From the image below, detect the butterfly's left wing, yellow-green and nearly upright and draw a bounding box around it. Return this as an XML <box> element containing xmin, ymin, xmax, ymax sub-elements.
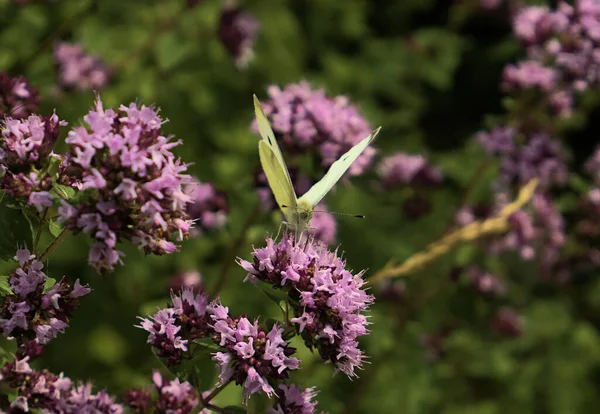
<box><xmin>254</xmin><ymin>95</ymin><xmax>298</xmax><ymax>220</ymax></box>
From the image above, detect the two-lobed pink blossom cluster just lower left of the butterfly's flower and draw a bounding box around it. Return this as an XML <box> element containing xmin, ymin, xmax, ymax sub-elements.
<box><xmin>140</xmin><ymin>288</ymin><xmax>299</xmax><ymax>400</ymax></box>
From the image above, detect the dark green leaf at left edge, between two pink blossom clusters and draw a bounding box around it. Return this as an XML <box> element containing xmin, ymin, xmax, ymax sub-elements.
<box><xmin>0</xmin><ymin>197</ymin><xmax>33</xmax><ymax>261</ymax></box>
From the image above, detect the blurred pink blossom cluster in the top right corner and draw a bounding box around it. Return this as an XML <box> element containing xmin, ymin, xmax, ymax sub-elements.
<box><xmin>504</xmin><ymin>0</ymin><xmax>600</xmax><ymax>117</ymax></box>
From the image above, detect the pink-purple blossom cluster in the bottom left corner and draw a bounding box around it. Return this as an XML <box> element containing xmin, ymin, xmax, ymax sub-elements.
<box><xmin>0</xmin><ymin>357</ymin><xmax>124</xmax><ymax>414</ymax></box>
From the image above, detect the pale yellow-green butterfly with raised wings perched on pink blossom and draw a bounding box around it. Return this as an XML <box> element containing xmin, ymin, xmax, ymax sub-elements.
<box><xmin>254</xmin><ymin>95</ymin><xmax>381</xmax><ymax>240</ymax></box>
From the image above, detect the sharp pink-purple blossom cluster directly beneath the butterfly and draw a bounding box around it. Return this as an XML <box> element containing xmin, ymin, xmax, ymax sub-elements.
<box><xmin>238</xmin><ymin>235</ymin><xmax>373</xmax><ymax>377</ymax></box>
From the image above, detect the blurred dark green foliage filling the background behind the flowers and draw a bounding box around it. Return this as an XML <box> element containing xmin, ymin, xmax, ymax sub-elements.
<box><xmin>0</xmin><ymin>0</ymin><xmax>600</xmax><ymax>414</ymax></box>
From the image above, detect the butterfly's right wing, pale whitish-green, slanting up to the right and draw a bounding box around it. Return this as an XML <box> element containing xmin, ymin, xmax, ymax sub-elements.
<box><xmin>298</xmin><ymin>127</ymin><xmax>381</xmax><ymax>209</ymax></box>
